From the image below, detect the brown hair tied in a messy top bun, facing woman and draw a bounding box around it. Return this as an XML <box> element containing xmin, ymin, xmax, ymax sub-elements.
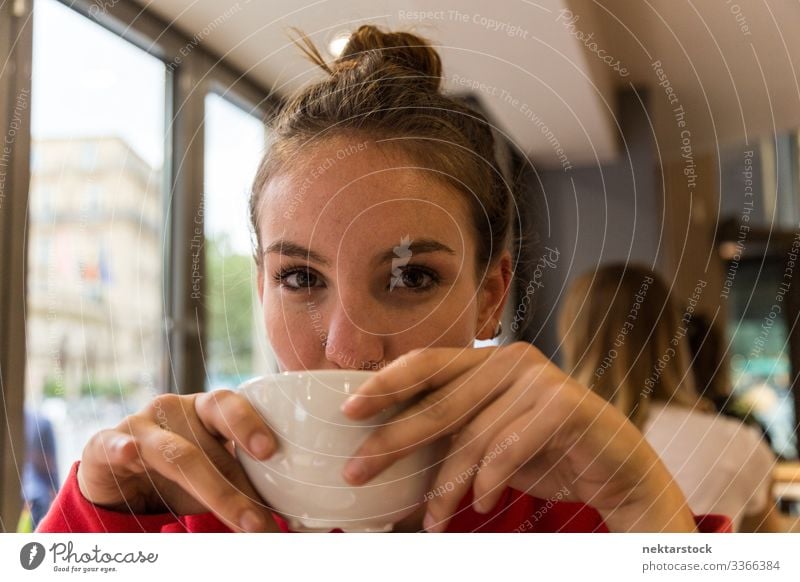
<box><xmin>250</xmin><ymin>25</ymin><xmax>513</xmax><ymax>274</ymax></box>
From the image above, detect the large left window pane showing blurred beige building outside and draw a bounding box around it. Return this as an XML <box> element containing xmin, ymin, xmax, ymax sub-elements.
<box><xmin>23</xmin><ymin>0</ymin><xmax>166</xmax><ymax>532</ymax></box>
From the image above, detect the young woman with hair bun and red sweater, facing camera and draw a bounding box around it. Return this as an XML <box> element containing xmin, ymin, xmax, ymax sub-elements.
<box><xmin>38</xmin><ymin>26</ymin><xmax>729</xmax><ymax>532</ymax></box>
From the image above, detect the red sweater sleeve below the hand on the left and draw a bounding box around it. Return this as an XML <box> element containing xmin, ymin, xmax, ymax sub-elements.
<box><xmin>36</xmin><ymin>461</ymin><xmax>183</xmax><ymax>533</ymax></box>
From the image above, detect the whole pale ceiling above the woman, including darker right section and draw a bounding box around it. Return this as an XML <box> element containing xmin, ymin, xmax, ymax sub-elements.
<box><xmin>141</xmin><ymin>0</ymin><xmax>800</xmax><ymax>167</ymax></box>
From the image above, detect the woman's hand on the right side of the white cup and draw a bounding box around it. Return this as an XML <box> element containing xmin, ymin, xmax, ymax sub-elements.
<box><xmin>343</xmin><ymin>342</ymin><xmax>696</xmax><ymax>531</ymax></box>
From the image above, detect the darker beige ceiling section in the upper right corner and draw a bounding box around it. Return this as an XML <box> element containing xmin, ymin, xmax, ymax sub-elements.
<box><xmin>588</xmin><ymin>0</ymin><xmax>800</xmax><ymax>158</ymax></box>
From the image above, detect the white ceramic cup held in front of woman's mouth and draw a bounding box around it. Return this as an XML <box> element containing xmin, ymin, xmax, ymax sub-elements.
<box><xmin>236</xmin><ymin>370</ymin><xmax>446</xmax><ymax>532</ymax></box>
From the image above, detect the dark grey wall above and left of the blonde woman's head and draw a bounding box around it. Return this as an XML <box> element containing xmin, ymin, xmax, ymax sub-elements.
<box><xmin>518</xmin><ymin>90</ymin><xmax>666</xmax><ymax>361</ymax></box>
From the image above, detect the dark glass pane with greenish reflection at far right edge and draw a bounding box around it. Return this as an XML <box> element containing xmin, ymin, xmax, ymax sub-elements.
<box><xmin>728</xmin><ymin>259</ymin><xmax>797</xmax><ymax>459</ymax></box>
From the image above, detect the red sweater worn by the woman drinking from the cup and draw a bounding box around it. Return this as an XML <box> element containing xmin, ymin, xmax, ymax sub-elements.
<box><xmin>36</xmin><ymin>461</ymin><xmax>732</xmax><ymax>533</ymax></box>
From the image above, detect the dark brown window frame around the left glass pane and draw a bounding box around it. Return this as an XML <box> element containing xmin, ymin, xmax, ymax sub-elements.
<box><xmin>0</xmin><ymin>0</ymin><xmax>281</xmax><ymax>531</ymax></box>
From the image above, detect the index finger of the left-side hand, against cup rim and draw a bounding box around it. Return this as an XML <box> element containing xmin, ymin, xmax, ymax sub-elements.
<box><xmin>194</xmin><ymin>390</ymin><xmax>276</xmax><ymax>460</ymax></box>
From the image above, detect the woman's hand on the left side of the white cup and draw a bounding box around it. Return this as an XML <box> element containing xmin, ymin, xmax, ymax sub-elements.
<box><xmin>78</xmin><ymin>390</ymin><xmax>278</xmax><ymax>531</ymax></box>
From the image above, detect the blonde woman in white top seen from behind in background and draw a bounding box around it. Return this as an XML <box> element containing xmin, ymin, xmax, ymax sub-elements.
<box><xmin>559</xmin><ymin>264</ymin><xmax>785</xmax><ymax>531</ymax></box>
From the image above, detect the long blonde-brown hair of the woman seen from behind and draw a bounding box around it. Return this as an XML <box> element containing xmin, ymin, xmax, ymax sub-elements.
<box><xmin>558</xmin><ymin>264</ymin><xmax>712</xmax><ymax>428</ymax></box>
